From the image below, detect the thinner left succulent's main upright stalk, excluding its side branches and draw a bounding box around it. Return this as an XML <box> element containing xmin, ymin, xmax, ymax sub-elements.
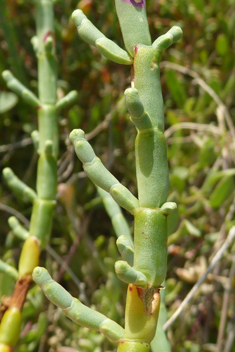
<box><xmin>0</xmin><ymin>0</ymin><xmax>58</xmax><ymax>352</ymax></box>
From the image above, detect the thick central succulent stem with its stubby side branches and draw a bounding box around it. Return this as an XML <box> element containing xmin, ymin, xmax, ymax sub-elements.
<box><xmin>33</xmin><ymin>0</ymin><xmax>182</xmax><ymax>352</ymax></box>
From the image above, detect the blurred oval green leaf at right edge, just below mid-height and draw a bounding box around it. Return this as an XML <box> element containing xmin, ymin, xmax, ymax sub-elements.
<box><xmin>210</xmin><ymin>176</ymin><xmax>234</xmax><ymax>208</ymax></box>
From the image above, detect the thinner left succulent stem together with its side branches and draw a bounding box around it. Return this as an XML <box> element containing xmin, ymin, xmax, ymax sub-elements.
<box><xmin>0</xmin><ymin>0</ymin><xmax>77</xmax><ymax>352</ymax></box>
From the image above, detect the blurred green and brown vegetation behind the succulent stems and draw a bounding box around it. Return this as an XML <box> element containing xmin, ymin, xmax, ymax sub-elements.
<box><xmin>0</xmin><ymin>0</ymin><xmax>235</xmax><ymax>352</ymax></box>
